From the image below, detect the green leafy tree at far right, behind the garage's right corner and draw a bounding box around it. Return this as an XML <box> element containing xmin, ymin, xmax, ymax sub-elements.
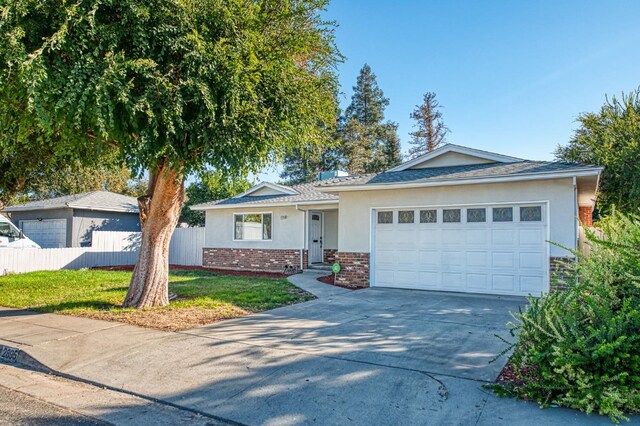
<box><xmin>555</xmin><ymin>89</ymin><xmax>640</xmax><ymax>213</ymax></box>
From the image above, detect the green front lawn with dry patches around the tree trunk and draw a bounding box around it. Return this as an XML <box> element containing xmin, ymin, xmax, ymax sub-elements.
<box><xmin>0</xmin><ymin>270</ymin><xmax>314</xmax><ymax>331</ymax></box>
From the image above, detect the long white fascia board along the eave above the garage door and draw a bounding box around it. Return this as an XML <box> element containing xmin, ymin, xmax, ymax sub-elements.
<box><xmin>316</xmin><ymin>167</ymin><xmax>603</xmax><ymax>193</ymax></box>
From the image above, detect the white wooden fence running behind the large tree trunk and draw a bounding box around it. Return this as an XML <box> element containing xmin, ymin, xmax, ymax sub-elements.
<box><xmin>0</xmin><ymin>228</ymin><xmax>204</xmax><ymax>275</ymax></box>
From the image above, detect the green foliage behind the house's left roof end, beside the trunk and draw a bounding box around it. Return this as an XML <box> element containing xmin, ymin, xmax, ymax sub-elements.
<box><xmin>180</xmin><ymin>171</ymin><xmax>251</xmax><ymax>226</ymax></box>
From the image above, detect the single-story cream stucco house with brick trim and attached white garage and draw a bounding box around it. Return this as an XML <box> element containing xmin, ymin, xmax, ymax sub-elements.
<box><xmin>192</xmin><ymin>145</ymin><xmax>602</xmax><ymax>295</ymax></box>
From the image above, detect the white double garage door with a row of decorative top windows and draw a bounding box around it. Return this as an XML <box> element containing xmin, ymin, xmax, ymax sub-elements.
<box><xmin>373</xmin><ymin>204</ymin><xmax>548</xmax><ymax>295</ymax></box>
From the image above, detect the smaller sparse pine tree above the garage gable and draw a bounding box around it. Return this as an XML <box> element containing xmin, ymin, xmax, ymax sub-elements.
<box><xmin>409</xmin><ymin>92</ymin><xmax>449</xmax><ymax>158</ymax></box>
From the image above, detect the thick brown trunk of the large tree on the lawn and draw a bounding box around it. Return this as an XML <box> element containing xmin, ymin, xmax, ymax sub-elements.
<box><xmin>124</xmin><ymin>166</ymin><xmax>184</xmax><ymax>308</ymax></box>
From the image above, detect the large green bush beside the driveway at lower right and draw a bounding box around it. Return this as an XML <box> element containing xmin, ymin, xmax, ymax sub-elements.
<box><xmin>495</xmin><ymin>211</ymin><xmax>640</xmax><ymax>422</ymax></box>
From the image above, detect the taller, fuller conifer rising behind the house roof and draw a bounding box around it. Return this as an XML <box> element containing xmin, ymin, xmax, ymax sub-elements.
<box><xmin>340</xmin><ymin>64</ymin><xmax>401</xmax><ymax>174</ymax></box>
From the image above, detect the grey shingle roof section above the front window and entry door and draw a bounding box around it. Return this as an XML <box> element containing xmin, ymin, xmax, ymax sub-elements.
<box><xmin>192</xmin><ymin>182</ymin><xmax>338</xmax><ymax>210</ymax></box>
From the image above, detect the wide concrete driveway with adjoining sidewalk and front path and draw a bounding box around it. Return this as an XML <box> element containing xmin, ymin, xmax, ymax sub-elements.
<box><xmin>0</xmin><ymin>272</ymin><xmax>640</xmax><ymax>425</ymax></box>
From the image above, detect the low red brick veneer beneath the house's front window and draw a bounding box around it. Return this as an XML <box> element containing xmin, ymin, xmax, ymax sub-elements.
<box><xmin>202</xmin><ymin>248</ymin><xmax>307</xmax><ymax>272</ymax></box>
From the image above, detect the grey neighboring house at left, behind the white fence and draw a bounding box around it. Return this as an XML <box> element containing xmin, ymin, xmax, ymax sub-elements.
<box><xmin>3</xmin><ymin>191</ymin><xmax>140</xmax><ymax>248</ymax></box>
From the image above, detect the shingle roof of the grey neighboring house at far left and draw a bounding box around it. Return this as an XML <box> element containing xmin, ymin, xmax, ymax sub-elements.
<box><xmin>3</xmin><ymin>191</ymin><xmax>138</xmax><ymax>213</ymax></box>
